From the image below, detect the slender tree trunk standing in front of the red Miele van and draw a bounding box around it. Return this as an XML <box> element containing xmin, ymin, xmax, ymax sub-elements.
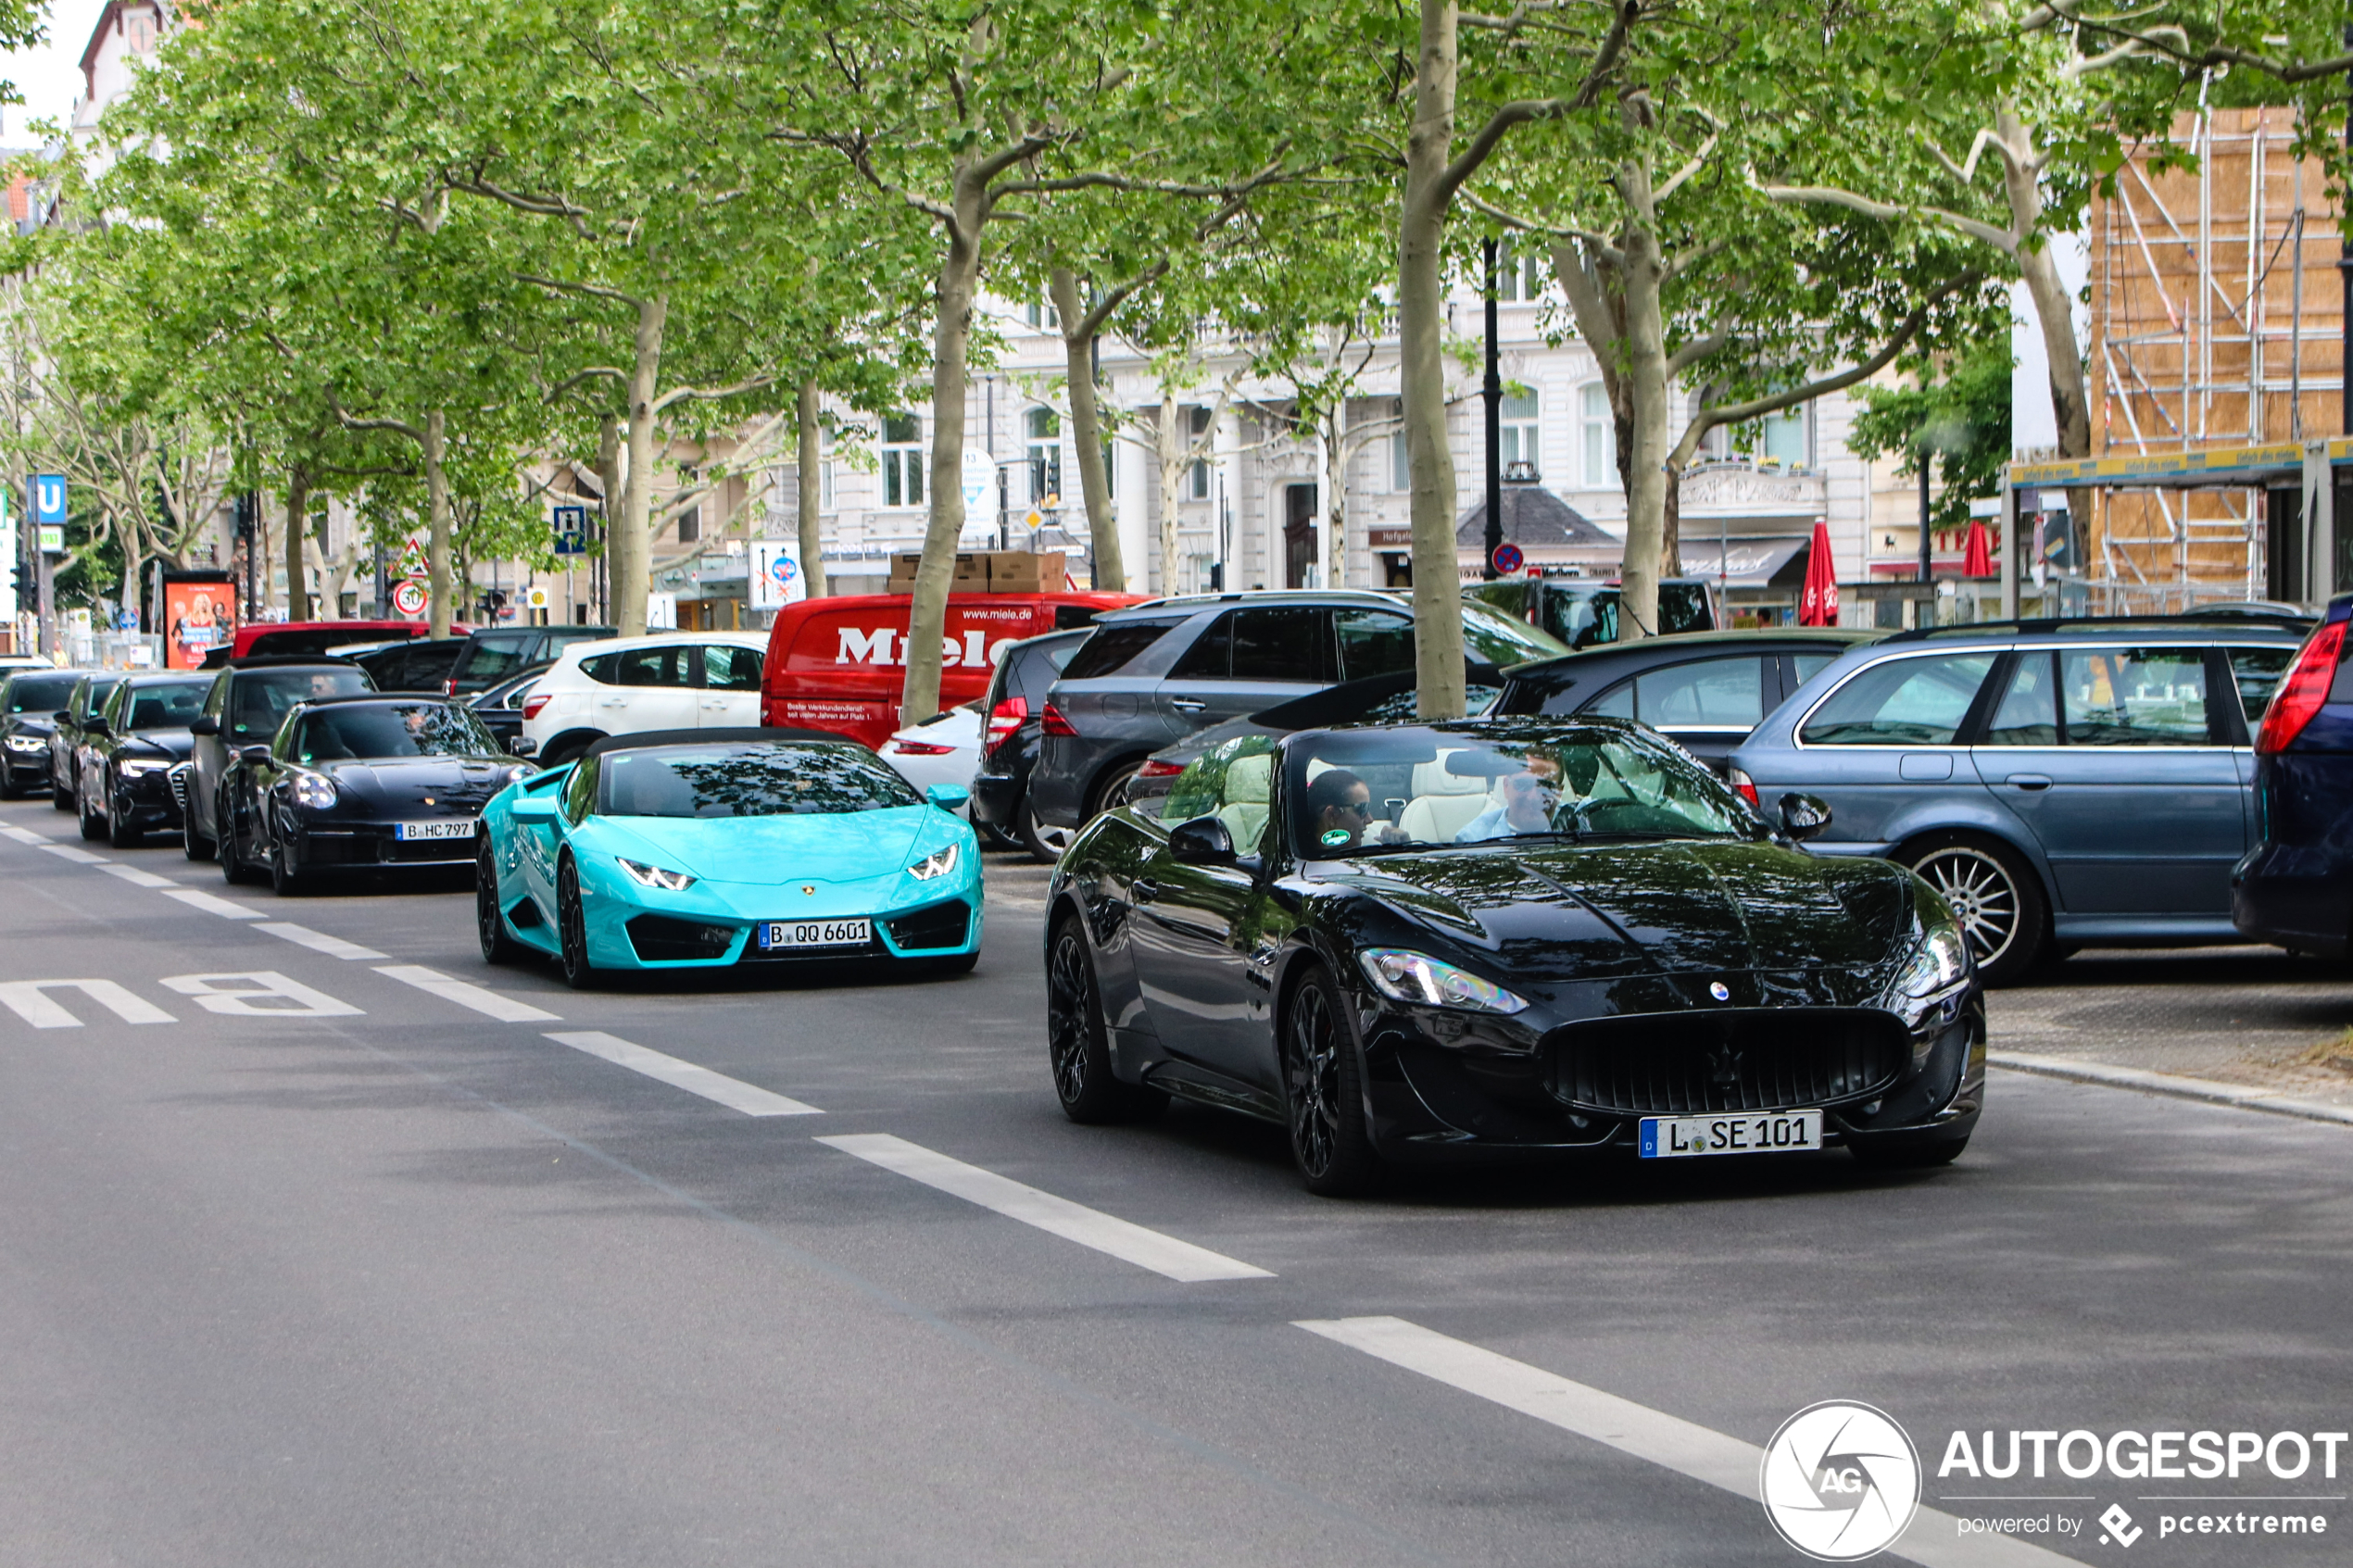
<box><xmin>899</xmin><ymin>186</ymin><xmax>986</xmax><ymax>724</ymax></box>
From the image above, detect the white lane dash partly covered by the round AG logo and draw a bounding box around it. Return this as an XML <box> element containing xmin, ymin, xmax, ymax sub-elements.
<box><xmin>1294</xmin><ymin>1316</ymin><xmax>2075</xmax><ymax>1568</ymax></box>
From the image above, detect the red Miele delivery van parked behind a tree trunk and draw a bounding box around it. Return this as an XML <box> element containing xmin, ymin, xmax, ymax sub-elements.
<box><xmin>760</xmin><ymin>593</ymin><xmax>1143</xmax><ymax>750</ymax></box>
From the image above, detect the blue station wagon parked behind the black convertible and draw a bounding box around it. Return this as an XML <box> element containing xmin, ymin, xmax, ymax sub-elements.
<box><xmin>1731</xmin><ymin>619</ymin><xmax>2299</xmax><ymax>983</ymax></box>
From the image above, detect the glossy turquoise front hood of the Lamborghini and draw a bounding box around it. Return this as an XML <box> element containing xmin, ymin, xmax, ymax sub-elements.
<box><xmin>598</xmin><ymin>807</ymin><xmax>963</xmax><ymax>884</ymax></box>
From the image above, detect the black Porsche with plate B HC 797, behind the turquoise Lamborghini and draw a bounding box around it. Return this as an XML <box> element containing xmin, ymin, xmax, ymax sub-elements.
<box><xmin>217</xmin><ymin>694</ymin><xmax>532</xmax><ymax>894</ymax></box>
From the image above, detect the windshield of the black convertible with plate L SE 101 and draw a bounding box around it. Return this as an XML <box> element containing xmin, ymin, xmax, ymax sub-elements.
<box><xmin>1285</xmin><ymin>726</ymin><xmax>1757</xmax><ymax>858</ymax></box>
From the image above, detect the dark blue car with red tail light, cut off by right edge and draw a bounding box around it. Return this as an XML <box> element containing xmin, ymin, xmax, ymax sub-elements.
<box><xmin>2231</xmin><ymin>593</ymin><xmax>2353</xmax><ymax>960</ymax></box>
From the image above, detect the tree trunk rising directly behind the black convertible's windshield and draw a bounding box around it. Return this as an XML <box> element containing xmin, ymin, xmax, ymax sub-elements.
<box><xmin>1398</xmin><ymin>0</ymin><xmax>1464</xmax><ymax>720</ymax></box>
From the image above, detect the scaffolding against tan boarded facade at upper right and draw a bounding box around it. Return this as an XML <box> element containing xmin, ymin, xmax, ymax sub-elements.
<box><xmin>2084</xmin><ymin>108</ymin><xmax>2346</xmax><ymax>595</ymax></box>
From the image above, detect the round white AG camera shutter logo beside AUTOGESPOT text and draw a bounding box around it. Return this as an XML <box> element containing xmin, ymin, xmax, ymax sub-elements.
<box><xmin>1757</xmin><ymin>1399</ymin><xmax>1920</xmax><ymax>1563</ymax></box>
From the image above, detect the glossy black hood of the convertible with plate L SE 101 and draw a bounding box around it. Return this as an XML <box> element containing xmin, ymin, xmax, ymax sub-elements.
<box><xmin>1329</xmin><ymin>842</ymin><xmax>1913</xmax><ymax>980</ymax></box>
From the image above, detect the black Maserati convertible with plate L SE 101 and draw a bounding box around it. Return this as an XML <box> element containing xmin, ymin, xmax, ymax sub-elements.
<box><xmin>1047</xmin><ymin>720</ymin><xmax>1986</xmax><ymax>1194</ymax></box>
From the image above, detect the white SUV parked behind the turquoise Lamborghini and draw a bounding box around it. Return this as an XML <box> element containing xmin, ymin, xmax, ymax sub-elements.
<box><xmin>522</xmin><ymin>633</ymin><xmax>767</xmax><ymax>766</ymax></box>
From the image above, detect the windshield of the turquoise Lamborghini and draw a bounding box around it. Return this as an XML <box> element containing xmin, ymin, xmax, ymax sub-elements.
<box><xmin>596</xmin><ymin>741</ymin><xmax>923</xmax><ymax>818</ymax></box>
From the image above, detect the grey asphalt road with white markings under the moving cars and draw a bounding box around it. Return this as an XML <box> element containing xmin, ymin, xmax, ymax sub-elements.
<box><xmin>0</xmin><ymin>802</ymin><xmax>2353</xmax><ymax>1568</ymax></box>
